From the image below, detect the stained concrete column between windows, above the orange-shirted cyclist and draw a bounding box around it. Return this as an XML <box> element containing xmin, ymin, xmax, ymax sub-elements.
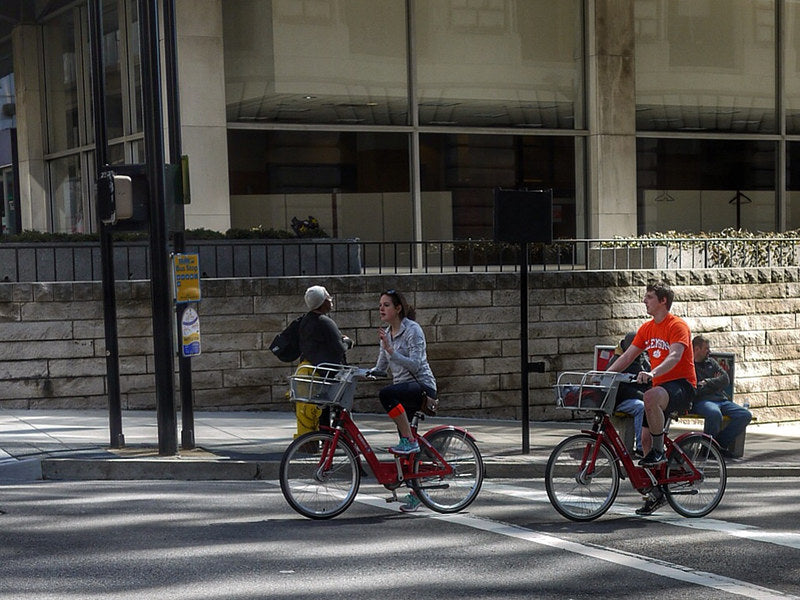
<box><xmin>586</xmin><ymin>0</ymin><xmax>637</xmax><ymax>238</ymax></box>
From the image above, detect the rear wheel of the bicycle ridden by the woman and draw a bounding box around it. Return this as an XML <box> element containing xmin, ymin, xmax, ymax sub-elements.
<box><xmin>410</xmin><ymin>429</ymin><xmax>483</xmax><ymax>513</ymax></box>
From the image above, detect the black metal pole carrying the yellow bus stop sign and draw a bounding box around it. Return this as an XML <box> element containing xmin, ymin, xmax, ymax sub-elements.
<box><xmin>164</xmin><ymin>0</ymin><xmax>195</xmax><ymax>450</ymax></box>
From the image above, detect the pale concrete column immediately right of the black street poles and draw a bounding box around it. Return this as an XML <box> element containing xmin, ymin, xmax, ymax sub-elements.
<box><xmin>175</xmin><ymin>0</ymin><xmax>231</xmax><ymax>231</ymax></box>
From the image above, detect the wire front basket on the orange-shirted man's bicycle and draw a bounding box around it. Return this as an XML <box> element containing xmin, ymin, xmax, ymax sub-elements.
<box><xmin>555</xmin><ymin>371</ymin><xmax>630</xmax><ymax>414</ymax></box>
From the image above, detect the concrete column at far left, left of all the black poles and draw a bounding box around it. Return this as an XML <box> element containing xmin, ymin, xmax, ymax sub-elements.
<box><xmin>11</xmin><ymin>24</ymin><xmax>50</xmax><ymax>231</ymax></box>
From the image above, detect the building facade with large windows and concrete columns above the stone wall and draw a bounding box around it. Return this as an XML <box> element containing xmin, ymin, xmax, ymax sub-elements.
<box><xmin>0</xmin><ymin>0</ymin><xmax>800</xmax><ymax>241</ymax></box>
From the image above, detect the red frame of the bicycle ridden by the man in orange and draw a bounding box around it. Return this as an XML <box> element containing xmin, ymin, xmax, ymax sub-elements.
<box><xmin>582</xmin><ymin>413</ymin><xmax>711</xmax><ymax>491</ymax></box>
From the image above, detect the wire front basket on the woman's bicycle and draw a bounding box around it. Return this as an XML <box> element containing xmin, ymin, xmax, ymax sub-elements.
<box><xmin>289</xmin><ymin>363</ymin><xmax>358</xmax><ymax>410</ymax></box>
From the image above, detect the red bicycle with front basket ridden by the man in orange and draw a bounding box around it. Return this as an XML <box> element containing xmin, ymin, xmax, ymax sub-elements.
<box><xmin>545</xmin><ymin>371</ymin><xmax>727</xmax><ymax>521</ymax></box>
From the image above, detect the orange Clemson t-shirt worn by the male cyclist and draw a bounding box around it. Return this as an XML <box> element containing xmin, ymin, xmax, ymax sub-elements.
<box><xmin>633</xmin><ymin>313</ymin><xmax>697</xmax><ymax>387</ymax></box>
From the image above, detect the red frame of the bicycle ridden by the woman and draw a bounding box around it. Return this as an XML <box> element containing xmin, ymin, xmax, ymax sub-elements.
<box><xmin>320</xmin><ymin>408</ymin><xmax>474</xmax><ymax>487</ymax></box>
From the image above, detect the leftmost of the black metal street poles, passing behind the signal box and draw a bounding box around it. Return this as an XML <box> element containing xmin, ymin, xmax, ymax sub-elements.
<box><xmin>88</xmin><ymin>0</ymin><xmax>125</xmax><ymax>448</ymax></box>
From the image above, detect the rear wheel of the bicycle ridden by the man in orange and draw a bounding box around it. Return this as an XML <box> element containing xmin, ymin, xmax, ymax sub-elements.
<box><xmin>664</xmin><ymin>434</ymin><xmax>728</xmax><ymax>517</ymax></box>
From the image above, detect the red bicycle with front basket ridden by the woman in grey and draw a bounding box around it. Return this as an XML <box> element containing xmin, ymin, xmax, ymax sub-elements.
<box><xmin>280</xmin><ymin>364</ymin><xmax>484</xmax><ymax>519</ymax></box>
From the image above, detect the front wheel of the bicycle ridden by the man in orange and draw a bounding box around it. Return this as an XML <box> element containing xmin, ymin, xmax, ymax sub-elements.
<box><xmin>544</xmin><ymin>434</ymin><xmax>619</xmax><ymax>521</ymax></box>
